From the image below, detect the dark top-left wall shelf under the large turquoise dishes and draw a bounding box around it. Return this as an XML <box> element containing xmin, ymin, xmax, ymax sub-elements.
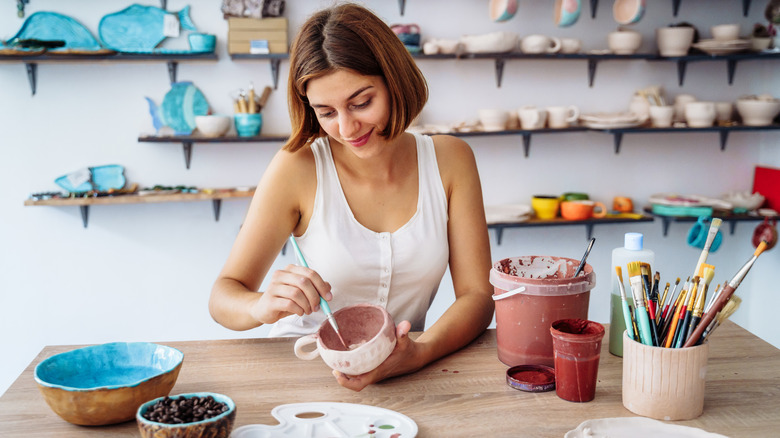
<box><xmin>0</xmin><ymin>53</ymin><xmax>217</xmax><ymax>96</ymax></box>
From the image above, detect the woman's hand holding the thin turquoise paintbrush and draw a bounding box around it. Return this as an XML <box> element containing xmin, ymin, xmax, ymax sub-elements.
<box><xmin>249</xmin><ymin>265</ymin><xmax>333</xmax><ymax>324</ymax></box>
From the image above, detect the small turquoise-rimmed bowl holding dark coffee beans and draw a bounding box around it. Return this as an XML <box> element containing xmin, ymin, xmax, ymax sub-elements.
<box><xmin>135</xmin><ymin>392</ymin><xmax>236</xmax><ymax>438</ymax></box>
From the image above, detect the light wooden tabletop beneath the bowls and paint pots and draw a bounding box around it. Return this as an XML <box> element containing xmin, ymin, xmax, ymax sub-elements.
<box><xmin>0</xmin><ymin>322</ymin><xmax>780</xmax><ymax>438</ymax></box>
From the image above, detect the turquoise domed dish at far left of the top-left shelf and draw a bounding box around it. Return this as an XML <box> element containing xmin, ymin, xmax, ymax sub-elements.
<box><xmin>7</xmin><ymin>12</ymin><xmax>103</xmax><ymax>52</ymax></box>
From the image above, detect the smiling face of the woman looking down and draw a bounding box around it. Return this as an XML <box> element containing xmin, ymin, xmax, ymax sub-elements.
<box><xmin>306</xmin><ymin>70</ymin><xmax>390</xmax><ymax>156</ymax></box>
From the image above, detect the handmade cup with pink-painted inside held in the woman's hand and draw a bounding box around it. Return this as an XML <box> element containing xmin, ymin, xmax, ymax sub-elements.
<box><xmin>295</xmin><ymin>304</ymin><xmax>396</xmax><ymax>376</ymax></box>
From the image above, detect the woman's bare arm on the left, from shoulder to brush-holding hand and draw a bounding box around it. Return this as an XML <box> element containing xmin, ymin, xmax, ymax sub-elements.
<box><xmin>209</xmin><ymin>148</ymin><xmax>331</xmax><ymax>330</ymax></box>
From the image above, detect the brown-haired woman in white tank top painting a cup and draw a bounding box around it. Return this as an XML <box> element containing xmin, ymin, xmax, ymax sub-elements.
<box><xmin>209</xmin><ymin>4</ymin><xmax>494</xmax><ymax>391</ymax></box>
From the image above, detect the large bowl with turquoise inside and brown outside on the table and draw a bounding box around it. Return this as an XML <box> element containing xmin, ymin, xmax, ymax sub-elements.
<box><xmin>34</xmin><ymin>342</ymin><xmax>184</xmax><ymax>426</ymax></box>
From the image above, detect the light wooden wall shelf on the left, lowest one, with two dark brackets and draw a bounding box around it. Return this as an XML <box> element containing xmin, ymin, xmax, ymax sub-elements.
<box><xmin>24</xmin><ymin>189</ymin><xmax>254</xmax><ymax>228</ymax></box>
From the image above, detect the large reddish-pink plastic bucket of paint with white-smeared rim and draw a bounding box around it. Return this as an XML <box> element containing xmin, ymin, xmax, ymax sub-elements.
<box><xmin>490</xmin><ymin>256</ymin><xmax>596</xmax><ymax>367</ymax></box>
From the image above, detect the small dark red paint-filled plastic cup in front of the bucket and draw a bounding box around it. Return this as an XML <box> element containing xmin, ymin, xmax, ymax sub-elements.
<box><xmin>550</xmin><ymin>319</ymin><xmax>604</xmax><ymax>402</ymax></box>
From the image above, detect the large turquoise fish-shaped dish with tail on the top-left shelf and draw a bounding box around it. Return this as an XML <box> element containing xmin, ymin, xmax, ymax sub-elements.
<box><xmin>98</xmin><ymin>4</ymin><xmax>197</xmax><ymax>53</ymax></box>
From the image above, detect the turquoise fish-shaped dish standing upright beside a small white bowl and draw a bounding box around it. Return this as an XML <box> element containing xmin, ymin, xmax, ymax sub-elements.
<box><xmin>146</xmin><ymin>81</ymin><xmax>209</xmax><ymax>135</ymax></box>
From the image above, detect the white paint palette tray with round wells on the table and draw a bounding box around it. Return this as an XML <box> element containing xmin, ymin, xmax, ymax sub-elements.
<box><xmin>230</xmin><ymin>402</ymin><xmax>418</xmax><ymax>438</ymax></box>
